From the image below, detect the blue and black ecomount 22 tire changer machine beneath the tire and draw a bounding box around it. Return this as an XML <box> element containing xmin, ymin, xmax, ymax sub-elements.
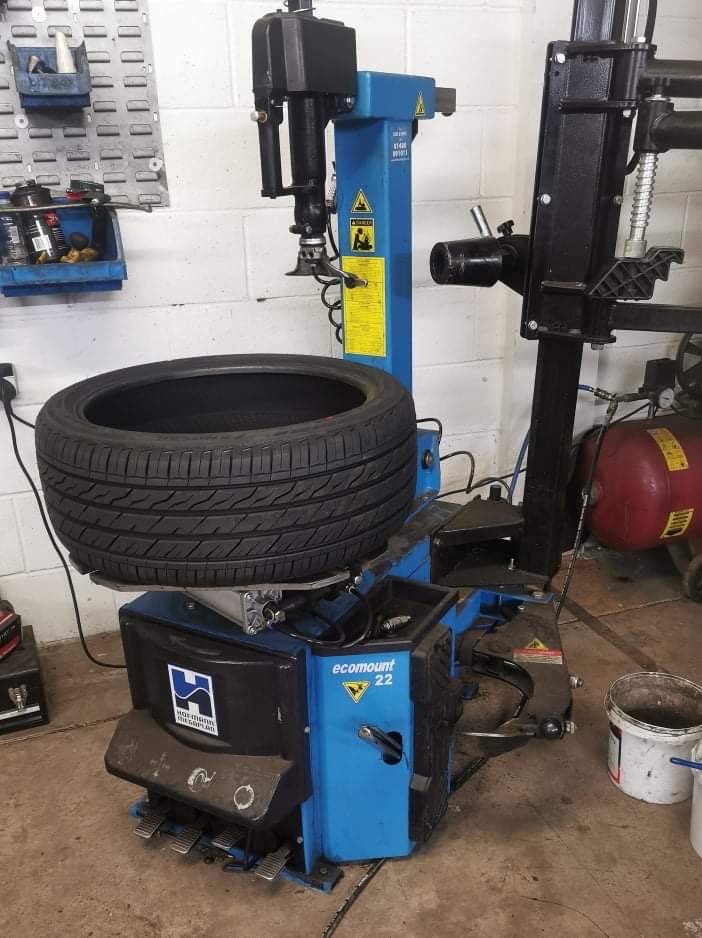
<box><xmin>106</xmin><ymin>0</ymin><xmax>702</xmax><ymax>890</ymax></box>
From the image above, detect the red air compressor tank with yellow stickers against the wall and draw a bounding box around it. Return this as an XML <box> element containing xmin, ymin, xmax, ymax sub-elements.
<box><xmin>578</xmin><ymin>416</ymin><xmax>702</xmax><ymax>550</ymax></box>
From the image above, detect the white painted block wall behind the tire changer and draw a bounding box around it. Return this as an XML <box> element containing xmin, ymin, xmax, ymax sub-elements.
<box><xmin>0</xmin><ymin>0</ymin><xmax>702</xmax><ymax>641</ymax></box>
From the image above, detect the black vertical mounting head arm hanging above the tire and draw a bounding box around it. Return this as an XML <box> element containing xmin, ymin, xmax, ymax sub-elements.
<box><xmin>252</xmin><ymin>0</ymin><xmax>357</xmax><ymax>276</ymax></box>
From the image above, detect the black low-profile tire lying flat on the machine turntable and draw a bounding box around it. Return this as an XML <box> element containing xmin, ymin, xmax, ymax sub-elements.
<box><xmin>36</xmin><ymin>355</ymin><xmax>416</xmax><ymax>587</ymax></box>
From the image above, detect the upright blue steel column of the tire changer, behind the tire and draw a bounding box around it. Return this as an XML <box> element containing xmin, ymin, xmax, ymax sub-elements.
<box><xmin>335</xmin><ymin>72</ymin><xmax>436</xmax><ymax>390</ymax></box>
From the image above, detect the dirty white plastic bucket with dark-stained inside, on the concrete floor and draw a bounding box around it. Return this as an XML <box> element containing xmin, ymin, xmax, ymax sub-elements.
<box><xmin>605</xmin><ymin>671</ymin><xmax>702</xmax><ymax>804</ymax></box>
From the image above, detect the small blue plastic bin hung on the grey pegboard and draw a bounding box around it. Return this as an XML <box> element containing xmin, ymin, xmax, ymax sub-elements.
<box><xmin>7</xmin><ymin>42</ymin><xmax>92</xmax><ymax>108</ymax></box>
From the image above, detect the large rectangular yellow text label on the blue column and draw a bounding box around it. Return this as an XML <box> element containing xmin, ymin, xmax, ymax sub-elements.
<box><xmin>343</xmin><ymin>257</ymin><xmax>386</xmax><ymax>358</ymax></box>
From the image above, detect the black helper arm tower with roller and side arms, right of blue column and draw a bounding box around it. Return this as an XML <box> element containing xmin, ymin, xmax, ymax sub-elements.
<box><xmin>431</xmin><ymin>0</ymin><xmax>702</xmax><ymax>579</ymax></box>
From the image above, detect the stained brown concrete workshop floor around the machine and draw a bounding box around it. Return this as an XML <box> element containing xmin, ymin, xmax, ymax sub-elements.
<box><xmin>0</xmin><ymin>558</ymin><xmax>702</xmax><ymax>938</ymax></box>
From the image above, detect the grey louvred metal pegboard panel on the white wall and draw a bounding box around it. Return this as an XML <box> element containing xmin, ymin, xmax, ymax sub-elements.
<box><xmin>0</xmin><ymin>0</ymin><xmax>168</xmax><ymax>205</ymax></box>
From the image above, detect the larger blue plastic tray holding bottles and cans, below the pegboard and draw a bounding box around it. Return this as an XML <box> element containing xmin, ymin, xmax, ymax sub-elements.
<box><xmin>0</xmin><ymin>202</ymin><xmax>127</xmax><ymax>296</ymax></box>
